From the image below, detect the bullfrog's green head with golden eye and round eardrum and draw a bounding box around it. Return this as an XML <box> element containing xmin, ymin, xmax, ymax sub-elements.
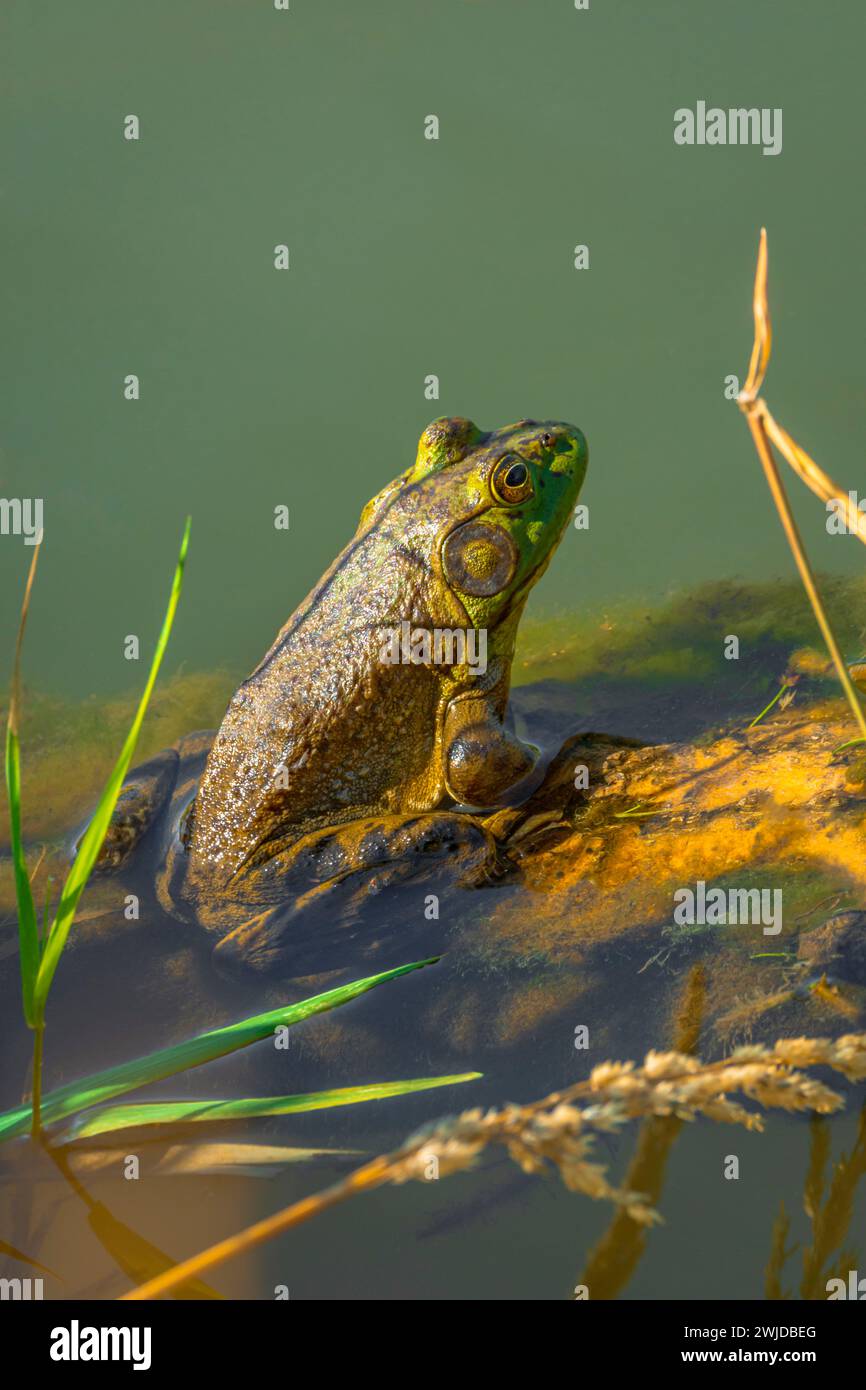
<box><xmin>414</xmin><ymin>418</ymin><xmax>588</xmax><ymax>627</ymax></box>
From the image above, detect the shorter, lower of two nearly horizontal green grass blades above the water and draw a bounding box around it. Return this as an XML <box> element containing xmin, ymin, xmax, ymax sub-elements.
<box><xmin>63</xmin><ymin>1072</ymin><xmax>481</xmax><ymax>1143</ymax></box>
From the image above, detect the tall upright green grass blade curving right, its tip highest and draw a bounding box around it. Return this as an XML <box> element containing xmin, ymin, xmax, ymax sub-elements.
<box><xmin>33</xmin><ymin>517</ymin><xmax>190</xmax><ymax>1017</ymax></box>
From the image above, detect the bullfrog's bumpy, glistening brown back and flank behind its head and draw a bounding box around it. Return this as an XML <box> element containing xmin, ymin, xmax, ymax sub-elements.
<box><xmin>190</xmin><ymin>500</ymin><xmax>464</xmax><ymax>877</ymax></box>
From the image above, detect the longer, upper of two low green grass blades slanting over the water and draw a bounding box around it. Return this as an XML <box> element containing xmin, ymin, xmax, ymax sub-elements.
<box><xmin>0</xmin><ymin>956</ymin><xmax>439</xmax><ymax>1143</ymax></box>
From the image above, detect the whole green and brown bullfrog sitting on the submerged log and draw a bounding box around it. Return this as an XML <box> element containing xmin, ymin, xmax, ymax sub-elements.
<box><xmin>96</xmin><ymin>418</ymin><xmax>587</xmax><ymax>972</ymax></box>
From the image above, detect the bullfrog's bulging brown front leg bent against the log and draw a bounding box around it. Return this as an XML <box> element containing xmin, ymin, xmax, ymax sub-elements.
<box><xmin>442</xmin><ymin>695</ymin><xmax>539</xmax><ymax>808</ymax></box>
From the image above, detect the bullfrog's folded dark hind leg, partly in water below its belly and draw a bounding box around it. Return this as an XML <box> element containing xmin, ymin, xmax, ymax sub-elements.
<box><xmin>214</xmin><ymin>812</ymin><xmax>502</xmax><ymax>974</ymax></box>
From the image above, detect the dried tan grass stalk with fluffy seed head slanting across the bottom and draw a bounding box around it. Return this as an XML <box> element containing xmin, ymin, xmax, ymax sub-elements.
<box><xmin>124</xmin><ymin>1033</ymin><xmax>866</xmax><ymax>1300</ymax></box>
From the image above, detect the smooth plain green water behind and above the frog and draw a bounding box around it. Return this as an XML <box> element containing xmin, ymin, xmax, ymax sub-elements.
<box><xmin>0</xmin><ymin>0</ymin><xmax>866</xmax><ymax>694</ymax></box>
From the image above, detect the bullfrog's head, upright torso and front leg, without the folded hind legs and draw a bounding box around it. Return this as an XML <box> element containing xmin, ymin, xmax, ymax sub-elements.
<box><xmin>166</xmin><ymin>418</ymin><xmax>588</xmax><ymax>916</ymax></box>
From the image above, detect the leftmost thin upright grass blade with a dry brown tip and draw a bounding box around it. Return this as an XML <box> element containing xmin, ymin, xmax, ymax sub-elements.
<box><xmin>6</xmin><ymin>542</ymin><xmax>42</xmax><ymax>1029</ymax></box>
